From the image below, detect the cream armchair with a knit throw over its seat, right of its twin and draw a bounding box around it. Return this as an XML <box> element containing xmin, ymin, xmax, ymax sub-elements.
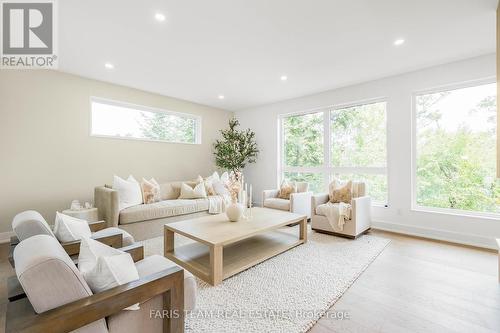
<box><xmin>311</xmin><ymin>182</ymin><xmax>371</xmax><ymax>239</ymax></box>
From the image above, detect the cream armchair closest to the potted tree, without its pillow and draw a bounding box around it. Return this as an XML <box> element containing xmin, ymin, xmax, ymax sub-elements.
<box><xmin>262</xmin><ymin>182</ymin><xmax>313</xmax><ymax>218</ymax></box>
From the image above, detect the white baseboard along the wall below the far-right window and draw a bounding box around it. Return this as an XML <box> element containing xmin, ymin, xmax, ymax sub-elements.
<box><xmin>372</xmin><ymin>221</ymin><xmax>498</xmax><ymax>250</ymax></box>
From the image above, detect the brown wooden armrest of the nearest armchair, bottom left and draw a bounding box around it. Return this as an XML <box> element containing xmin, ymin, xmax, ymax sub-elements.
<box><xmin>5</xmin><ymin>266</ymin><xmax>184</xmax><ymax>333</ymax></box>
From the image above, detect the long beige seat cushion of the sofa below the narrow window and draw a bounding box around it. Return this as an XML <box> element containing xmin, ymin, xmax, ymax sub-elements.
<box><xmin>120</xmin><ymin>199</ymin><xmax>208</xmax><ymax>224</ymax></box>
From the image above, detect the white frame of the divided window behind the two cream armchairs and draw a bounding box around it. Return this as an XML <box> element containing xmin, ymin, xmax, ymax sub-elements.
<box><xmin>277</xmin><ymin>97</ymin><xmax>390</xmax><ymax>208</ymax></box>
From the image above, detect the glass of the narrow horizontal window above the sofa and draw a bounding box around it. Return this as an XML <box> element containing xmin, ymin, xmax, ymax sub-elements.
<box><xmin>91</xmin><ymin>101</ymin><xmax>199</xmax><ymax>143</ymax></box>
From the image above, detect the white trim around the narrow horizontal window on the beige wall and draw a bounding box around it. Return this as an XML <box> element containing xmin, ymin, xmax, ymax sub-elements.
<box><xmin>89</xmin><ymin>96</ymin><xmax>202</xmax><ymax>145</ymax></box>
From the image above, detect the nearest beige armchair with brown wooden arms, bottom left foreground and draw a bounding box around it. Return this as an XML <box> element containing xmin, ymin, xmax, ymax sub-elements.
<box><xmin>7</xmin><ymin>235</ymin><xmax>197</xmax><ymax>333</ymax></box>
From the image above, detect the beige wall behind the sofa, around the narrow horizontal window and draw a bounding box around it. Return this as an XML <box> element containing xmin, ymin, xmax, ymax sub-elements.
<box><xmin>0</xmin><ymin>70</ymin><xmax>232</xmax><ymax>238</ymax></box>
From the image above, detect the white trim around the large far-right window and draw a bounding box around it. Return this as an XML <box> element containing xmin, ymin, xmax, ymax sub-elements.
<box><xmin>410</xmin><ymin>76</ymin><xmax>500</xmax><ymax>219</ymax></box>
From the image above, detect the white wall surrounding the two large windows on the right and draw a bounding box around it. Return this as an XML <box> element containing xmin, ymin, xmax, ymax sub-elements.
<box><xmin>236</xmin><ymin>54</ymin><xmax>500</xmax><ymax>248</ymax></box>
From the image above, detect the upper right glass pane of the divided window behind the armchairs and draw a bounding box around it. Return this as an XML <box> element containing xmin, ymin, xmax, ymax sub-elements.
<box><xmin>330</xmin><ymin>102</ymin><xmax>387</xmax><ymax>167</ymax></box>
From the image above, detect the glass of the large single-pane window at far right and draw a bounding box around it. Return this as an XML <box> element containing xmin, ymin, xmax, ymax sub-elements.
<box><xmin>416</xmin><ymin>84</ymin><xmax>500</xmax><ymax>213</ymax></box>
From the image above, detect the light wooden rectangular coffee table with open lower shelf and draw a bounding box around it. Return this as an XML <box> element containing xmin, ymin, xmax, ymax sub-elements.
<box><xmin>164</xmin><ymin>207</ymin><xmax>307</xmax><ymax>286</ymax></box>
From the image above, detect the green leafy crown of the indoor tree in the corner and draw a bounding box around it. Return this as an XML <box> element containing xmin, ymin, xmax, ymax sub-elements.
<box><xmin>214</xmin><ymin>118</ymin><xmax>259</xmax><ymax>174</ymax></box>
